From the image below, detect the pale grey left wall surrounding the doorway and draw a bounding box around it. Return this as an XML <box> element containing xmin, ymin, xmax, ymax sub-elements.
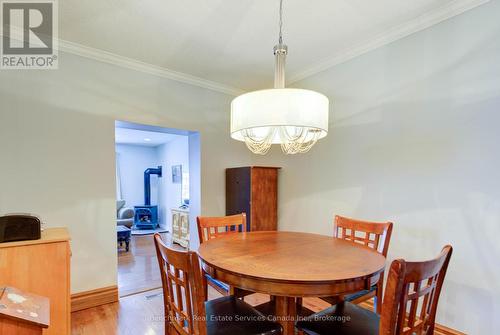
<box><xmin>0</xmin><ymin>53</ymin><xmax>252</xmax><ymax>293</ymax></box>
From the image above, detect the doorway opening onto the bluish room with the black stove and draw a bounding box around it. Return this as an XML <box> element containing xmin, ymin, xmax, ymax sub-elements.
<box><xmin>115</xmin><ymin>121</ymin><xmax>201</xmax><ymax>297</ymax></box>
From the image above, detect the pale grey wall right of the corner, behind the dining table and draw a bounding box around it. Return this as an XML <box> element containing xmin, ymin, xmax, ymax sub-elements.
<box><xmin>260</xmin><ymin>1</ymin><xmax>500</xmax><ymax>335</ymax></box>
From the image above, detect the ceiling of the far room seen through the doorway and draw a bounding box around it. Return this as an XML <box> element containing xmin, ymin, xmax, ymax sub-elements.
<box><xmin>115</xmin><ymin>128</ymin><xmax>181</xmax><ymax>147</ymax></box>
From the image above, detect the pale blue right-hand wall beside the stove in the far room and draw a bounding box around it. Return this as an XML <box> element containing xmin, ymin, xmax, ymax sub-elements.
<box><xmin>156</xmin><ymin>136</ymin><xmax>189</xmax><ymax>231</ymax></box>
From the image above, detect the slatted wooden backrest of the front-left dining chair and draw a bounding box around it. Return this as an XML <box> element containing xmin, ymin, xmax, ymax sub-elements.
<box><xmin>154</xmin><ymin>233</ymin><xmax>206</xmax><ymax>335</ymax></box>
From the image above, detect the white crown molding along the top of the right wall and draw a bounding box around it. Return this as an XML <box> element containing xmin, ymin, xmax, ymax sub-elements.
<box><xmin>287</xmin><ymin>0</ymin><xmax>490</xmax><ymax>84</ymax></box>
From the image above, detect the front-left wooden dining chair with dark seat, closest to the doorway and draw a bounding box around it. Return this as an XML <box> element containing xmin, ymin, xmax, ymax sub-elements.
<box><xmin>154</xmin><ymin>233</ymin><xmax>282</xmax><ymax>335</ymax></box>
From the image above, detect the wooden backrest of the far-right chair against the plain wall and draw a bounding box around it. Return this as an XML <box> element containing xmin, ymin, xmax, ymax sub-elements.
<box><xmin>333</xmin><ymin>215</ymin><xmax>392</xmax><ymax>257</ymax></box>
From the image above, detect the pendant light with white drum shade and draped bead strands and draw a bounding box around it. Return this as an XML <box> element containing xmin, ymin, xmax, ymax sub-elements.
<box><xmin>231</xmin><ymin>0</ymin><xmax>328</xmax><ymax>155</ymax></box>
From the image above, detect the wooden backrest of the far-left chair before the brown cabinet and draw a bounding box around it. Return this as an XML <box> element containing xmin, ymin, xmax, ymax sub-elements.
<box><xmin>196</xmin><ymin>213</ymin><xmax>247</xmax><ymax>243</ymax></box>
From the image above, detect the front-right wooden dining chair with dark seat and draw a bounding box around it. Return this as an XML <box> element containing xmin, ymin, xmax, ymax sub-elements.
<box><xmin>297</xmin><ymin>245</ymin><xmax>453</xmax><ymax>335</ymax></box>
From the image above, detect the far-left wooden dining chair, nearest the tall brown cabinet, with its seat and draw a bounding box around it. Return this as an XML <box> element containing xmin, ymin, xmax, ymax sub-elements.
<box><xmin>196</xmin><ymin>213</ymin><xmax>253</xmax><ymax>297</ymax></box>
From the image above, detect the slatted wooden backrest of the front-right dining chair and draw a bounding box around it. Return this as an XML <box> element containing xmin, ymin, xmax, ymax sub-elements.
<box><xmin>379</xmin><ymin>245</ymin><xmax>453</xmax><ymax>335</ymax></box>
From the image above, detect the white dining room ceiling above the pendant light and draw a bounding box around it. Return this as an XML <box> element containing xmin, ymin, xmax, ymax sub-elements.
<box><xmin>59</xmin><ymin>0</ymin><xmax>488</xmax><ymax>91</ymax></box>
